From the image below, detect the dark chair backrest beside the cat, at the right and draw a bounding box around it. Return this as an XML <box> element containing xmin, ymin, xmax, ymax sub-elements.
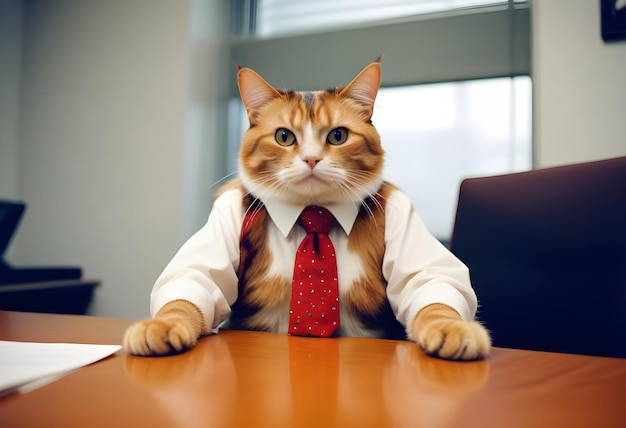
<box><xmin>450</xmin><ymin>157</ymin><xmax>626</xmax><ymax>357</ymax></box>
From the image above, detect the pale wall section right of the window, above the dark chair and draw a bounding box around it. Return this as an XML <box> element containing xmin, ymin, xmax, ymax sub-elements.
<box><xmin>532</xmin><ymin>0</ymin><xmax>626</xmax><ymax>167</ymax></box>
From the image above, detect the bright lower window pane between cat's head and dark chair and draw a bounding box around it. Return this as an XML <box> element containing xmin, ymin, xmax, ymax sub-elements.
<box><xmin>372</xmin><ymin>77</ymin><xmax>532</xmax><ymax>242</ymax></box>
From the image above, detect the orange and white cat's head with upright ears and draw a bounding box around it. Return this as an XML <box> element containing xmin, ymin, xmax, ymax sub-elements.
<box><xmin>237</xmin><ymin>61</ymin><xmax>384</xmax><ymax>205</ymax></box>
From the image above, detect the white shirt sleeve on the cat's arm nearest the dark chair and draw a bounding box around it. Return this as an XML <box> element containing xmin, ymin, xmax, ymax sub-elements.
<box><xmin>383</xmin><ymin>190</ymin><xmax>477</xmax><ymax>336</ymax></box>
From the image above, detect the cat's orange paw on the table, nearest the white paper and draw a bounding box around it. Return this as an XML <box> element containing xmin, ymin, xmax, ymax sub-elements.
<box><xmin>124</xmin><ymin>318</ymin><xmax>198</xmax><ymax>356</ymax></box>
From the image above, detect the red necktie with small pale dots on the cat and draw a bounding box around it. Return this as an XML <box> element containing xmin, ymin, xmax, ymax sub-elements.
<box><xmin>289</xmin><ymin>206</ymin><xmax>339</xmax><ymax>337</ymax></box>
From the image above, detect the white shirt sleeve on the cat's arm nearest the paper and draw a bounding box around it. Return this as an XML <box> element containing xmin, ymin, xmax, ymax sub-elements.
<box><xmin>150</xmin><ymin>190</ymin><xmax>243</xmax><ymax>333</ymax></box>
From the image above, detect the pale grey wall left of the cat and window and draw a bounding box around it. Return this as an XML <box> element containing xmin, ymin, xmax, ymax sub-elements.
<box><xmin>3</xmin><ymin>0</ymin><xmax>228</xmax><ymax>318</ymax></box>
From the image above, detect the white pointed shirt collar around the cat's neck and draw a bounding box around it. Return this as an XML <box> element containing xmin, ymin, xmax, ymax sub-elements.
<box><xmin>263</xmin><ymin>199</ymin><xmax>360</xmax><ymax>237</ymax></box>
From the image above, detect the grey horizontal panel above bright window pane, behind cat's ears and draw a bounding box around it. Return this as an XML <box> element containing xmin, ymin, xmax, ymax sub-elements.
<box><xmin>229</xmin><ymin>0</ymin><xmax>530</xmax><ymax>97</ymax></box>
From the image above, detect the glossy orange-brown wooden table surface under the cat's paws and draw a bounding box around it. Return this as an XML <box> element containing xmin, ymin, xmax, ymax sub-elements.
<box><xmin>0</xmin><ymin>311</ymin><xmax>626</xmax><ymax>428</ymax></box>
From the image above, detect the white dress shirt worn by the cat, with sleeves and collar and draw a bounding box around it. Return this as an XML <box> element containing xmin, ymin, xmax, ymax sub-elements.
<box><xmin>151</xmin><ymin>189</ymin><xmax>477</xmax><ymax>335</ymax></box>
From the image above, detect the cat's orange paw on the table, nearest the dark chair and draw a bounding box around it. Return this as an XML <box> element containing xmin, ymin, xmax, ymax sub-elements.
<box><xmin>411</xmin><ymin>304</ymin><xmax>491</xmax><ymax>361</ymax></box>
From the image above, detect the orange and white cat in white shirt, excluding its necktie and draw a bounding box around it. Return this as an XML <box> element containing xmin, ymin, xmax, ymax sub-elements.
<box><xmin>124</xmin><ymin>61</ymin><xmax>490</xmax><ymax>360</ymax></box>
